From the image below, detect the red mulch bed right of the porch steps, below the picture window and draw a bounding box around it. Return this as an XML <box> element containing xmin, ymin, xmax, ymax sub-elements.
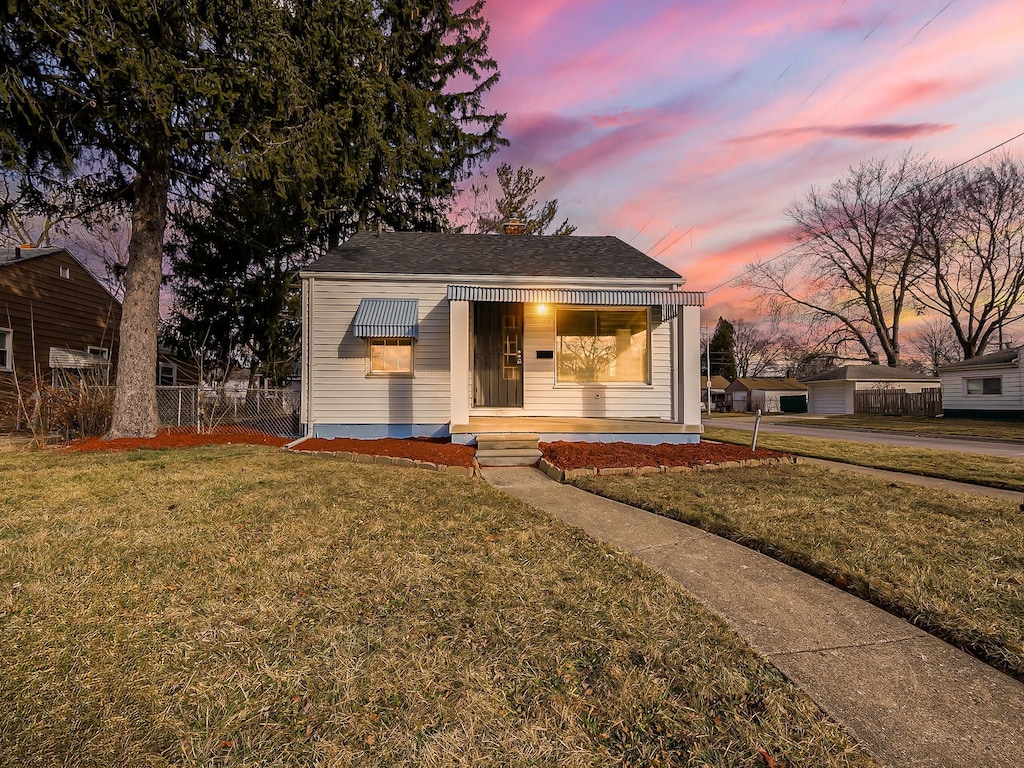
<box><xmin>541</xmin><ymin>441</ymin><xmax>786</xmax><ymax>469</ymax></box>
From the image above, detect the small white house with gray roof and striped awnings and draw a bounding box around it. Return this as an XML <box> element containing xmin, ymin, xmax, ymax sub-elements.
<box><xmin>301</xmin><ymin>232</ymin><xmax>703</xmax><ymax>443</ymax></box>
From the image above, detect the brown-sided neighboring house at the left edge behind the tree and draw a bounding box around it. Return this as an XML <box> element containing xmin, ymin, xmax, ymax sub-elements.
<box><xmin>0</xmin><ymin>247</ymin><xmax>121</xmax><ymax>410</ymax></box>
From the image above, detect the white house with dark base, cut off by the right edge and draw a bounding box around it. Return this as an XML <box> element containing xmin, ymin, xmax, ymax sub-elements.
<box><xmin>939</xmin><ymin>346</ymin><xmax>1024</xmax><ymax>420</ymax></box>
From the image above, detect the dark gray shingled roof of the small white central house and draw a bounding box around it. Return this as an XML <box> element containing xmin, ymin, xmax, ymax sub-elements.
<box><xmin>303</xmin><ymin>231</ymin><xmax>681</xmax><ymax>280</ymax></box>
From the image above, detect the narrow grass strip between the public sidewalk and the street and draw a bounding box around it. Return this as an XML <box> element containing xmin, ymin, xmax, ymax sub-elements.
<box><xmin>703</xmin><ymin>426</ymin><xmax>1024</xmax><ymax>492</ymax></box>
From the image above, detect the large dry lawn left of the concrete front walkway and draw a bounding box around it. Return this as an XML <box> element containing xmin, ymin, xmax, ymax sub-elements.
<box><xmin>0</xmin><ymin>445</ymin><xmax>873</xmax><ymax>768</ymax></box>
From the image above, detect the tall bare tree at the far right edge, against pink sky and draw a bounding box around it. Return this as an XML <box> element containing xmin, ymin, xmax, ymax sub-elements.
<box><xmin>902</xmin><ymin>156</ymin><xmax>1024</xmax><ymax>359</ymax></box>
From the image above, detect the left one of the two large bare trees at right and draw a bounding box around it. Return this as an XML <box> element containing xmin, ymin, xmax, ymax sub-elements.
<box><xmin>743</xmin><ymin>155</ymin><xmax>920</xmax><ymax>366</ymax></box>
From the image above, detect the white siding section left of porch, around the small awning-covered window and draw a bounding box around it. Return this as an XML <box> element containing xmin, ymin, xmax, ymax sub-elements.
<box><xmin>310</xmin><ymin>276</ymin><xmax>452</xmax><ymax>424</ymax></box>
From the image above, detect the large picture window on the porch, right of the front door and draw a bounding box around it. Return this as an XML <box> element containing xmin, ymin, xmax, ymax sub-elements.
<box><xmin>555</xmin><ymin>309</ymin><xmax>650</xmax><ymax>384</ymax></box>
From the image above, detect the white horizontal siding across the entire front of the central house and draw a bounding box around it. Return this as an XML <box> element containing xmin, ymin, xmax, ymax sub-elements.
<box><xmin>303</xmin><ymin>275</ymin><xmax>697</xmax><ymax>425</ymax></box>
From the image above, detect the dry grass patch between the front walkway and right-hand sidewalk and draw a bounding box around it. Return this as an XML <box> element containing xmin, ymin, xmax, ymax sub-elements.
<box><xmin>573</xmin><ymin>465</ymin><xmax>1024</xmax><ymax>680</ymax></box>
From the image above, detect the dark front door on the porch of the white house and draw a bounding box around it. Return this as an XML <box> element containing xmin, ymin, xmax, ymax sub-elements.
<box><xmin>473</xmin><ymin>302</ymin><xmax>522</xmax><ymax>408</ymax></box>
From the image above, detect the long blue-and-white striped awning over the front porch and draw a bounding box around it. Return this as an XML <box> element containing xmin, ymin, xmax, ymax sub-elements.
<box><xmin>447</xmin><ymin>286</ymin><xmax>705</xmax><ymax>307</ymax></box>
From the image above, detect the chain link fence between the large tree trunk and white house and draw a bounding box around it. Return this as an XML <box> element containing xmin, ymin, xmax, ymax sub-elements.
<box><xmin>157</xmin><ymin>387</ymin><xmax>299</xmax><ymax>437</ymax></box>
